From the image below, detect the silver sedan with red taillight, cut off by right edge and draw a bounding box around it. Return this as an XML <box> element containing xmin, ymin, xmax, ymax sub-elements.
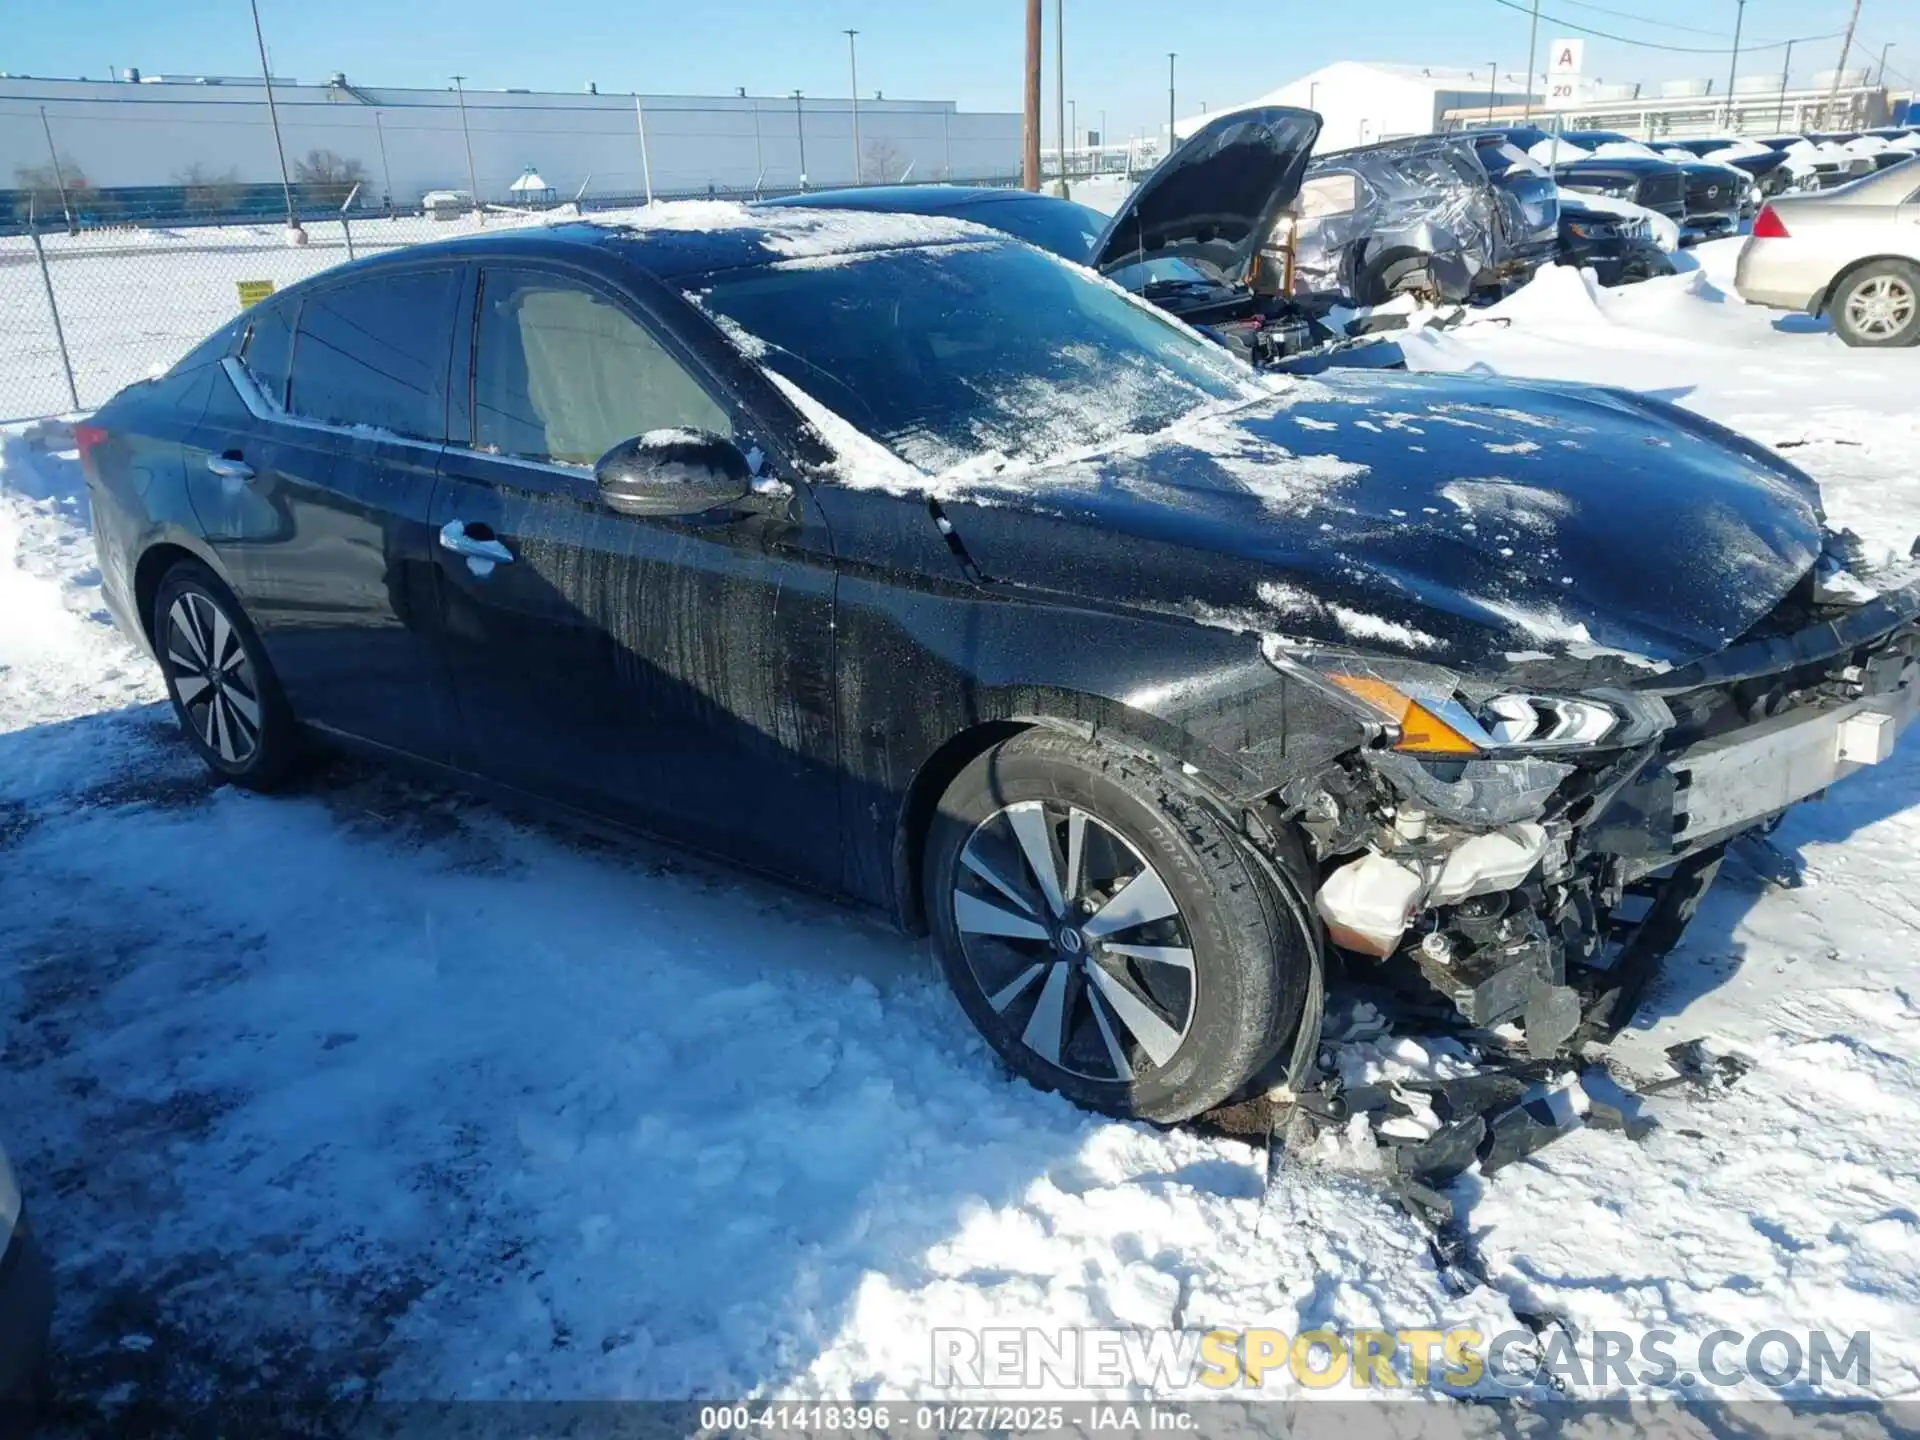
<box><xmin>1734</xmin><ymin>156</ymin><xmax>1920</xmax><ymax>346</ymax></box>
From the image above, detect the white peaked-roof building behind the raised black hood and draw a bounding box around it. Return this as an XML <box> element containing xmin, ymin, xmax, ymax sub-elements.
<box><xmin>1179</xmin><ymin>60</ymin><xmax>1528</xmax><ymax>150</ymax></box>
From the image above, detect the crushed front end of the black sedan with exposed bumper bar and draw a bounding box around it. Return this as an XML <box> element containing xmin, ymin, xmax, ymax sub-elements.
<box><xmin>1267</xmin><ymin>553</ymin><xmax>1920</xmax><ymax>1056</ymax></box>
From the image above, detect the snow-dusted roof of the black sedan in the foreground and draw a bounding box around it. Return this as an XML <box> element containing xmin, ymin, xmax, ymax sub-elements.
<box><xmin>278</xmin><ymin>200</ymin><xmax>1006</xmax><ymax>280</ymax></box>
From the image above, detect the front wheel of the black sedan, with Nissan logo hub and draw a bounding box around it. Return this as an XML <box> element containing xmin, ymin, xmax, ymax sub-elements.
<box><xmin>922</xmin><ymin>730</ymin><xmax>1311</xmax><ymax>1121</ymax></box>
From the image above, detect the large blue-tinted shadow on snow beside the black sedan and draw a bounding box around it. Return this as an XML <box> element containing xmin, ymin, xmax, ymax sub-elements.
<box><xmin>0</xmin><ymin>707</ymin><xmax>1221</xmax><ymax>1430</ymax></box>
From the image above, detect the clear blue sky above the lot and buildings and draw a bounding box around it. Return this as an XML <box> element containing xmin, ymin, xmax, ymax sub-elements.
<box><xmin>0</xmin><ymin>0</ymin><xmax>1920</xmax><ymax>134</ymax></box>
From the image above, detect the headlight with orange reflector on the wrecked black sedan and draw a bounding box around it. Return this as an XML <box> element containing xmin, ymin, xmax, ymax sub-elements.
<box><xmin>1267</xmin><ymin>643</ymin><xmax>1672</xmax><ymax>760</ymax></box>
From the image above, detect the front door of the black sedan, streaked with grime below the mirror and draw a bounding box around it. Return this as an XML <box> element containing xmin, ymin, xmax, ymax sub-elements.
<box><xmin>432</xmin><ymin>267</ymin><xmax>839</xmax><ymax>885</ymax></box>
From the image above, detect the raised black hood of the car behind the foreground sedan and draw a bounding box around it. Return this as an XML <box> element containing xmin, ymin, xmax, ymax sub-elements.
<box><xmin>1089</xmin><ymin>106</ymin><xmax>1321</xmax><ymax>280</ymax></box>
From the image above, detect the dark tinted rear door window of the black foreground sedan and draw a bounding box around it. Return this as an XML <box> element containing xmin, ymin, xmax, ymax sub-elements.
<box><xmin>286</xmin><ymin>269</ymin><xmax>459</xmax><ymax>440</ymax></box>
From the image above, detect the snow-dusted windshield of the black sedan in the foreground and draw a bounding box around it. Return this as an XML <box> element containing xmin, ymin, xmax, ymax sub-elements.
<box><xmin>687</xmin><ymin>242</ymin><xmax>1265</xmax><ymax>474</ymax></box>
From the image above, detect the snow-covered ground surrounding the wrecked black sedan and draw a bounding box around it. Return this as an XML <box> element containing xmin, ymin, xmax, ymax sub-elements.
<box><xmin>0</xmin><ymin>231</ymin><xmax>1920</xmax><ymax>1409</ymax></box>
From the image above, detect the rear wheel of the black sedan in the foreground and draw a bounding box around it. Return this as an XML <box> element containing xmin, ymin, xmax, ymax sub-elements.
<box><xmin>150</xmin><ymin>561</ymin><xmax>301</xmax><ymax>791</ymax></box>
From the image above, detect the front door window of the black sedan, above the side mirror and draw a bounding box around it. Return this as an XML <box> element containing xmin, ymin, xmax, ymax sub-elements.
<box><xmin>474</xmin><ymin>271</ymin><xmax>733</xmax><ymax>465</ymax></box>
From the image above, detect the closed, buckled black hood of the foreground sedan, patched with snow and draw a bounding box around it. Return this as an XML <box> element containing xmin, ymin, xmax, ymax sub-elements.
<box><xmin>941</xmin><ymin>372</ymin><xmax>1824</xmax><ymax>672</ymax></box>
